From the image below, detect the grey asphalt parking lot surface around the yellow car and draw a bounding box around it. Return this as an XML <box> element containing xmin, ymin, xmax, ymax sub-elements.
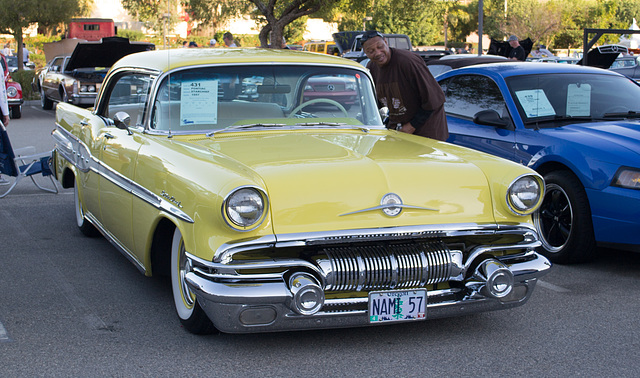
<box><xmin>0</xmin><ymin>102</ymin><xmax>640</xmax><ymax>377</ymax></box>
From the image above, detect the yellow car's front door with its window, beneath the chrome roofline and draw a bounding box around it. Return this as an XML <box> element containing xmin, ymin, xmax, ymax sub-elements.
<box><xmin>97</xmin><ymin>72</ymin><xmax>150</xmax><ymax>261</ymax></box>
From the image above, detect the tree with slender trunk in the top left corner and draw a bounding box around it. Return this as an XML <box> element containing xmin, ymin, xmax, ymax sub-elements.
<box><xmin>0</xmin><ymin>0</ymin><xmax>80</xmax><ymax>70</ymax></box>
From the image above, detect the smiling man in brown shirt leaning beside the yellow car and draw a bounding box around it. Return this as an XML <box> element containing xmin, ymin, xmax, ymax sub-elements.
<box><xmin>361</xmin><ymin>31</ymin><xmax>449</xmax><ymax>141</ymax></box>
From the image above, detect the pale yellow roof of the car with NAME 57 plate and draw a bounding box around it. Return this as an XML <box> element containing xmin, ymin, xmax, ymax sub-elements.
<box><xmin>112</xmin><ymin>48</ymin><xmax>363</xmax><ymax>72</ymax></box>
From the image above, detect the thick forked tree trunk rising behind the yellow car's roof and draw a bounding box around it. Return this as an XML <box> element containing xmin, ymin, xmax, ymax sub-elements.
<box><xmin>249</xmin><ymin>0</ymin><xmax>339</xmax><ymax>48</ymax></box>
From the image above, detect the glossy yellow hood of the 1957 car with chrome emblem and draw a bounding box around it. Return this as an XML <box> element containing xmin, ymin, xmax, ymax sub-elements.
<box><xmin>191</xmin><ymin>133</ymin><xmax>522</xmax><ymax>234</ymax></box>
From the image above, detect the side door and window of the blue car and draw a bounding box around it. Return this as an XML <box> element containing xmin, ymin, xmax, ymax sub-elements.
<box><xmin>440</xmin><ymin>74</ymin><xmax>516</xmax><ymax>160</ymax></box>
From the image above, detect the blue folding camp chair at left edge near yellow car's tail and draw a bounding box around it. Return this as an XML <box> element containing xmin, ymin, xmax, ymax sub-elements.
<box><xmin>0</xmin><ymin>123</ymin><xmax>58</xmax><ymax>198</ymax></box>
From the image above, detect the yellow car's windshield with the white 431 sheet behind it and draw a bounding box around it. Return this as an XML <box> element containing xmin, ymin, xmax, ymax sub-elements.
<box><xmin>151</xmin><ymin>64</ymin><xmax>382</xmax><ymax>132</ymax></box>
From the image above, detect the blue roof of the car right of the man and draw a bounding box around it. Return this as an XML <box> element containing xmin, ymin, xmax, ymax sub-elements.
<box><xmin>442</xmin><ymin>62</ymin><xmax>620</xmax><ymax>77</ymax></box>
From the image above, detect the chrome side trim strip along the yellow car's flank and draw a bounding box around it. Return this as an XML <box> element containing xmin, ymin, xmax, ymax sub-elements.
<box><xmin>52</xmin><ymin>122</ymin><xmax>194</xmax><ymax>223</ymax></box>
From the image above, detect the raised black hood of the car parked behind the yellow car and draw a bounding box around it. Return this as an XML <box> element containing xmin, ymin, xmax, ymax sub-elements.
<box><xmin>65</xmin><ymin>37</ymin><xmax>155</xmax><ymax>71</ymax></box>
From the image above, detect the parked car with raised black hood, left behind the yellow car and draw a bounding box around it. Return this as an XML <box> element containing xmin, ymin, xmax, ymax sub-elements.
<box><xmin>31</xmin><ymin>37</ymin><xmax>155</xmax><ymax>110</ymax></box>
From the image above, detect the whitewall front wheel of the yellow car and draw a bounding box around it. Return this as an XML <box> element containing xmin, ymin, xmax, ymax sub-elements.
<box><xmin>171</xmin><ymin>227</ymin><xmax>215</xmax><ymax>335</ymax></box>
